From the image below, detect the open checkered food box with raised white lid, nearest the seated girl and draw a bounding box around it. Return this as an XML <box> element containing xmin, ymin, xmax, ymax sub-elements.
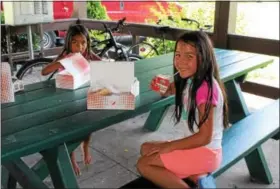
<box><xmin>87</xmin><ymin>61</ymin><xmax>139</xmax><ymax>110</ymax></box>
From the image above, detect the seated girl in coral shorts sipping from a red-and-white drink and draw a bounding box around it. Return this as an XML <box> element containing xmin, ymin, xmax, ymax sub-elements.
<box><xmin>137</xmin><ymin>31</ymin><xmax>228</xmax><ymax>188</ymax></box>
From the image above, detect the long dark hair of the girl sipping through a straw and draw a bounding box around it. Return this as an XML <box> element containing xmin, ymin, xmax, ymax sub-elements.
<box><xmin>173</xmin><ymin>31</ymin><xmax>229</xmax><ymax>132</ymax></box>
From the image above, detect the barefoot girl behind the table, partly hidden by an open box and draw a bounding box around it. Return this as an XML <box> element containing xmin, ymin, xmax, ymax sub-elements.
<box><xmin>42</xmin><ymin>24</ymin><xmax>101</xmax><ymax>175</ymax></box>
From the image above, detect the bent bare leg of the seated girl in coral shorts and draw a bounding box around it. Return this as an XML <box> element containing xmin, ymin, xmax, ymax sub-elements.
<box><xmin>137</xmin><ymin>154</ymin><xmax>189</xmax><ymax>188</ymax></box>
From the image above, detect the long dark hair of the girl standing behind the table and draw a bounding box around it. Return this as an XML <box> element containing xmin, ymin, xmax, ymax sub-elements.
<box><xmin>56</xmin><ymin>20</ymin><xmax>100</xmax><ymax>60</ymax></box>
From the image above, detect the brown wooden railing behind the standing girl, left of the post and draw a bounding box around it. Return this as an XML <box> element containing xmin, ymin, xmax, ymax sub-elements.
<box><xmin>1</xmin><ymin>18</ymin><xmax>212</xmax><ymax>59</ymax></box>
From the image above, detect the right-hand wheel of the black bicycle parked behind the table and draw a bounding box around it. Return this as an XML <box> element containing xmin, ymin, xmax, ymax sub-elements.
<box><xmin>127</xmin><ymin>42</ymin><xmax>159</xmax><ymax>58</ymax></box>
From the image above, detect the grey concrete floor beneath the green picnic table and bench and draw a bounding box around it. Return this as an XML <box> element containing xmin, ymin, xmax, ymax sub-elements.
<box><xmin>18</xmin><ymin>94</ymin><xmax>279</xmax><ymax>188</ymax></box>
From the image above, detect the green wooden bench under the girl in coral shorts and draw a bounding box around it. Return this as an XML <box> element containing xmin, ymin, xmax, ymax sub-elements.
<box><xmin>121</xmin><ymin>99</ymin><xmax>279</xmax><ymax>188</ymax></box>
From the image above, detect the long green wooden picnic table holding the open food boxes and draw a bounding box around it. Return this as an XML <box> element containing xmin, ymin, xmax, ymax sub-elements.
<box><xmin>1</xmin><ymin>49</ymin><xmax>278</xmax><ymax>189</ymax></box>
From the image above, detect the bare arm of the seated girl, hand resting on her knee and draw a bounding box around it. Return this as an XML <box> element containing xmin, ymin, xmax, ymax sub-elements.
<box><xmin>166</xmin><ymin>104</ymin><xmax>214</xmax><ymax>151</ymax></box>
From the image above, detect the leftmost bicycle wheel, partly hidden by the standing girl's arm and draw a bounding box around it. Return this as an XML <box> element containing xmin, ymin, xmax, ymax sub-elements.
<box><xmin>16</xmin><ymin>58</ymin><xmax>53</xmax><ymax>85</ymax></box>
